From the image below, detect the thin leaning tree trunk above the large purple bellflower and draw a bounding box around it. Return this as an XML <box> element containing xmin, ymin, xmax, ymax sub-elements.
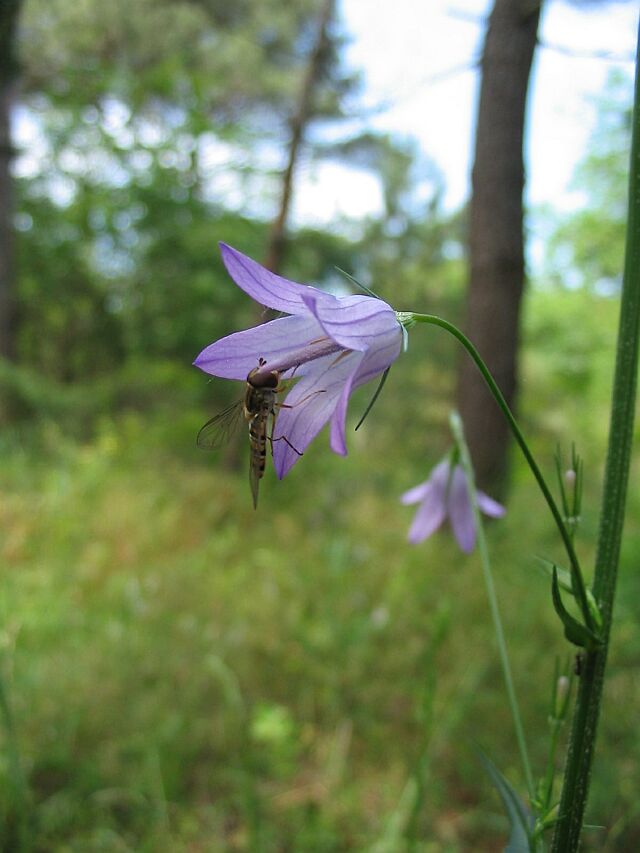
<box><xmin>265</xmin><ymin>0</ymin><xmax>335</xmax><ymax>272</ymax></box>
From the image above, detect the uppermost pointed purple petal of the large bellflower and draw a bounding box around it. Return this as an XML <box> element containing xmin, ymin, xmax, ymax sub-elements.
<box><xmin>220</xmin><ymin>243</ymin><xmax>333</xmax><ymax>314</ymax></box>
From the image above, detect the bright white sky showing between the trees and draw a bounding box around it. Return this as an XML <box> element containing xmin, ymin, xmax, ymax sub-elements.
<box><xmin>293</xmin><ymin>0</ymin><xmax>638</xmax><ymax>223</ymax></box>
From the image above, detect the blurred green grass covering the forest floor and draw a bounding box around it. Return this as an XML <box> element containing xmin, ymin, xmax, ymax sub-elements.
<box><xmin>0</xmin><ymin>288</ymin><xmax>640</xmax><ymax>853</ymax></box>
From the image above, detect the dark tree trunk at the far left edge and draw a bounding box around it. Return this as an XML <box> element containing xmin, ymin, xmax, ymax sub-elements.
<box><xmin>0</xmin><ymin>0</ymin><xmax>21</xmax><ymax>359</ymax></box>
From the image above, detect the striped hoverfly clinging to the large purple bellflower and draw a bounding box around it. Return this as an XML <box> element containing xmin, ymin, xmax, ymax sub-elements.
<box><xmin>196</xmin><ymin>358</ymin><xmax>302</xmax><ymax>509</ymax></box>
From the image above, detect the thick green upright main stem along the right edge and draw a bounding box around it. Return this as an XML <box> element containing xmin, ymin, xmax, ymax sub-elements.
<box><xmin>552</xmin><ymin>21</ymin><xmax>640</xmax><ymax>853</ymax></box>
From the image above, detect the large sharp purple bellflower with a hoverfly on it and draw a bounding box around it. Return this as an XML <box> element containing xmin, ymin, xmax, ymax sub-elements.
<box><xmin>194</xmin><ymin>243</ymin><xmax>403</xmax><ymax>479</ymax></box>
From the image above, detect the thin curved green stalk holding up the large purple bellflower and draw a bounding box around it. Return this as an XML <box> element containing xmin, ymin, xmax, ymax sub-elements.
<box><xmin>400</xmin><ymin>313</ymin><xmax>597</xmax><ymax>633</ymax></box>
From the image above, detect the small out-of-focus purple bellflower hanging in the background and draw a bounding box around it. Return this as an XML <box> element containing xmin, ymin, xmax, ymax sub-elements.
<box><xmin>400</xmin><ymin>458</ymin><xmax>506</xmax><ymax>554</ymax></box>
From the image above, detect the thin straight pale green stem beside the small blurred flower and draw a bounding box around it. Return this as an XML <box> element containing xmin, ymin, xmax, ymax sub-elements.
<box><xmin>449</xmin><ymin>412</ymin><xmax>535</xmax><ymax>802</ymax></box>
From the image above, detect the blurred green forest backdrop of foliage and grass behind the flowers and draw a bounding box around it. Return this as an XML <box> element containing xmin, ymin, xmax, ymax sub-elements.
<box><xmin>0</xmin><ymin>0</ymin><xmax>640</xmax><ymax>851</ymax></box>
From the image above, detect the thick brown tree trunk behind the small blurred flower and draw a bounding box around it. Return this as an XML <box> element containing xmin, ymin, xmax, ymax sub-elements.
<box><xmin>458</xmin><ymin>0</ymin><xmax>541</xmax><ymax>491</ymax></box>
